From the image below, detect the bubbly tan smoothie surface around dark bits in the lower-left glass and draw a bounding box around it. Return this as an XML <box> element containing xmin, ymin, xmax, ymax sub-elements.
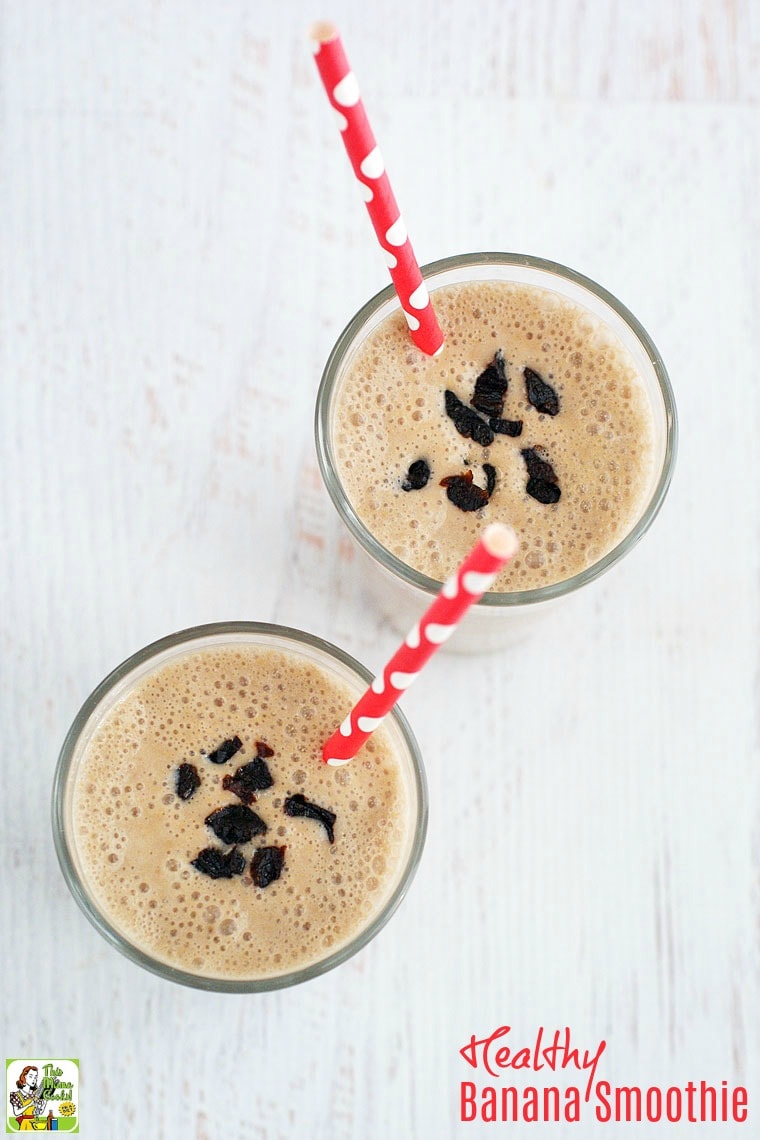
<box><xmin>73</xmin><ymin>646</ymin><xmax>414</xmax><ymax>978</ymax></box>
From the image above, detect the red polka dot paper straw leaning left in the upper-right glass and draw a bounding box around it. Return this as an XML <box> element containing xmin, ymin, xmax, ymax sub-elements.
<box><xmin>311</xmin><ymin>24</ymin><xmax>443</xmax><ymax>356</ymax></box>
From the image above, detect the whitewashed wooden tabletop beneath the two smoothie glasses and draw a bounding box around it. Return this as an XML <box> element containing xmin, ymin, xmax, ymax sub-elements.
<box><xmin>0</xmin><ymin>0</ymin><xmax>760</xmax><ymax>1140</ymax></box>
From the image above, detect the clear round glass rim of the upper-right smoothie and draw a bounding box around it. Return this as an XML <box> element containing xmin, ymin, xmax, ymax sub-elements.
<box><xmin>314</xmin><ymin>252</ymin><xmax>678</xmax><ymax>609</ymax></box>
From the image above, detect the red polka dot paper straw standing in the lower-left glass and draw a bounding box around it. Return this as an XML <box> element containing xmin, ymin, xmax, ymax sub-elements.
<box><xmin>322</xmin><ymin>522</ymin><xmax>517</xmax><ymax>765</ymax></box>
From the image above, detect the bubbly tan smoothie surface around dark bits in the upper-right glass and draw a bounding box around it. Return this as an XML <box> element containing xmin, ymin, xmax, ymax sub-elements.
<box><xmin>333</xmin><ymin>282</ymin><xmax>654</xmax><ymax>591</ymax></box>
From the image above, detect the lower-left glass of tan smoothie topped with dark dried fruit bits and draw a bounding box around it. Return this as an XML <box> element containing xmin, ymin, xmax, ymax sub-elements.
<box><xmin>54</xmin><ymin>624</ymin><xmax>426</xmax><ymax>990</ymax></box>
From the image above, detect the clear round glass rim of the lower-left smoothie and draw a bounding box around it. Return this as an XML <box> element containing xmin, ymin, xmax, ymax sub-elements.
<box><xmin>51</xmin><ymin>621</ymin><xmax>428</xmax><ymax>993</ymax></box>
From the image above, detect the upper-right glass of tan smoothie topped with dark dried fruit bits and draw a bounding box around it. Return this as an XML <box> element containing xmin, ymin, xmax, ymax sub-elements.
<box><xmin>317</xmin><ymin>254</ymin><xmax>676</xmax><ymax>650</ymax></box>
